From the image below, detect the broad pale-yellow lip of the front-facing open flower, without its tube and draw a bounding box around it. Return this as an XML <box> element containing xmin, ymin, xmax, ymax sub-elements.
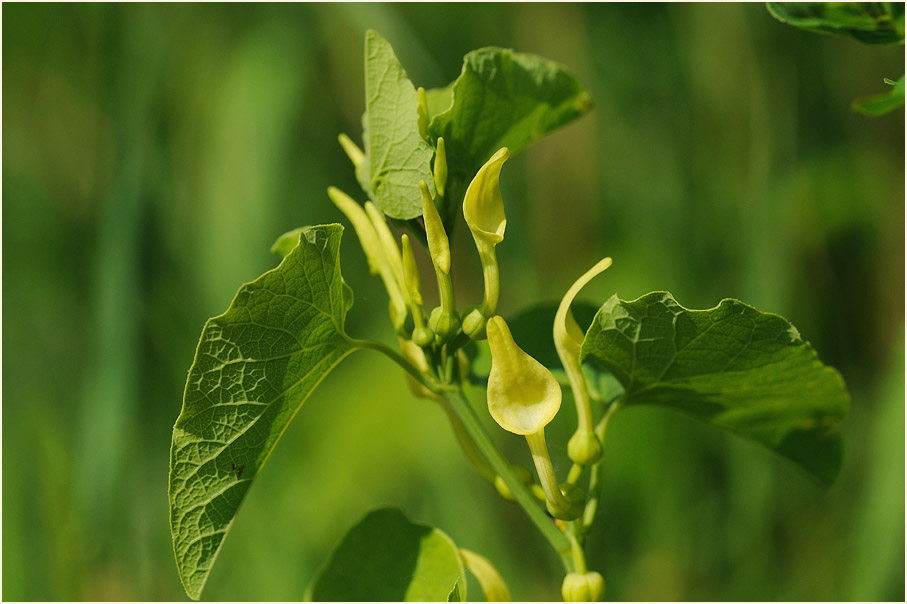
<box><xmin>486</xmin><ymin>316</ymin><xmax>561</xmax><ymax>435</ymax></box>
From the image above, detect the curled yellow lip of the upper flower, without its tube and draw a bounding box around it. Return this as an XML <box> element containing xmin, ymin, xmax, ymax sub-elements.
<box><xmin>463</xmin><ymin>147</ymin><xmax>510</xmax><ymax>245</ymax></box>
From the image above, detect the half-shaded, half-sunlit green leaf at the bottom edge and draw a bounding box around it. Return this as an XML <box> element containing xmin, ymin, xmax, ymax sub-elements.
<box><xmin>306</xmin><ymin>508</ymin><xmax>466</xmax><ymax>602</ymax></box>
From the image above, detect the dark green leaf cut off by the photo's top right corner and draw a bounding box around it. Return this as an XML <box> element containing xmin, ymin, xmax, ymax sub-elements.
<box><xmin>766</xmin><ymin>2</ymin><xmax>904</xmax><ymax>44</ymax></box>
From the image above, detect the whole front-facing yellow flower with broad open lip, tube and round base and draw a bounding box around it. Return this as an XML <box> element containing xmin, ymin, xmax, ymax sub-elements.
<box><xmin>487</xmin><ymin>316</ymin><xmax>583</xmax><ymax>520</ymax></box>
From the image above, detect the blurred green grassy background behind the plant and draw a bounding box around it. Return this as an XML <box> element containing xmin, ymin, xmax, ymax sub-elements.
<box><xmin>2</xmin><ymin>4</ymin><xmax>905</xmax><ymax>600</ymax></box>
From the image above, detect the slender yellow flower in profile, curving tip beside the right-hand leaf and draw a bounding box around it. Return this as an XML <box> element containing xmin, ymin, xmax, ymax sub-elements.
<box><xmin>554</xmin><ymin>258</ymin><xmax>611</xmax><ymax>466</ymax></box>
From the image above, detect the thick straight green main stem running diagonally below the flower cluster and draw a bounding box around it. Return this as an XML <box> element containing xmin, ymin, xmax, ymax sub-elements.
<box><xmin>442</xmin><ymin>388</ymin><xmax>574</xmax><ymax>572</ymax></box>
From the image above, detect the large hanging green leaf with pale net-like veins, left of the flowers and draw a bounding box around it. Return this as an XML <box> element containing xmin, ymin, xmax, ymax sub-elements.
<box><xmin>170</xmin><ymin>224</ymin><xmax>355</xmax><ymax>599</ymax></box>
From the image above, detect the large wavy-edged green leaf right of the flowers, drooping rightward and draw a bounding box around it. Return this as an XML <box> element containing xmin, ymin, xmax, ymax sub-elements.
<box><xmin>581</xmin><ymin>292</ymin><xmax>850</xmax><ymax>484</ymax></box>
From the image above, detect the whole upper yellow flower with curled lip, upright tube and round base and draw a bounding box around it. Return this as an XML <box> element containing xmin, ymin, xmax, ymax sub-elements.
<box><xmin>463</xmin><ymin>147</ymin><xmax>510</xmax><ymax>338</ymax></box>
